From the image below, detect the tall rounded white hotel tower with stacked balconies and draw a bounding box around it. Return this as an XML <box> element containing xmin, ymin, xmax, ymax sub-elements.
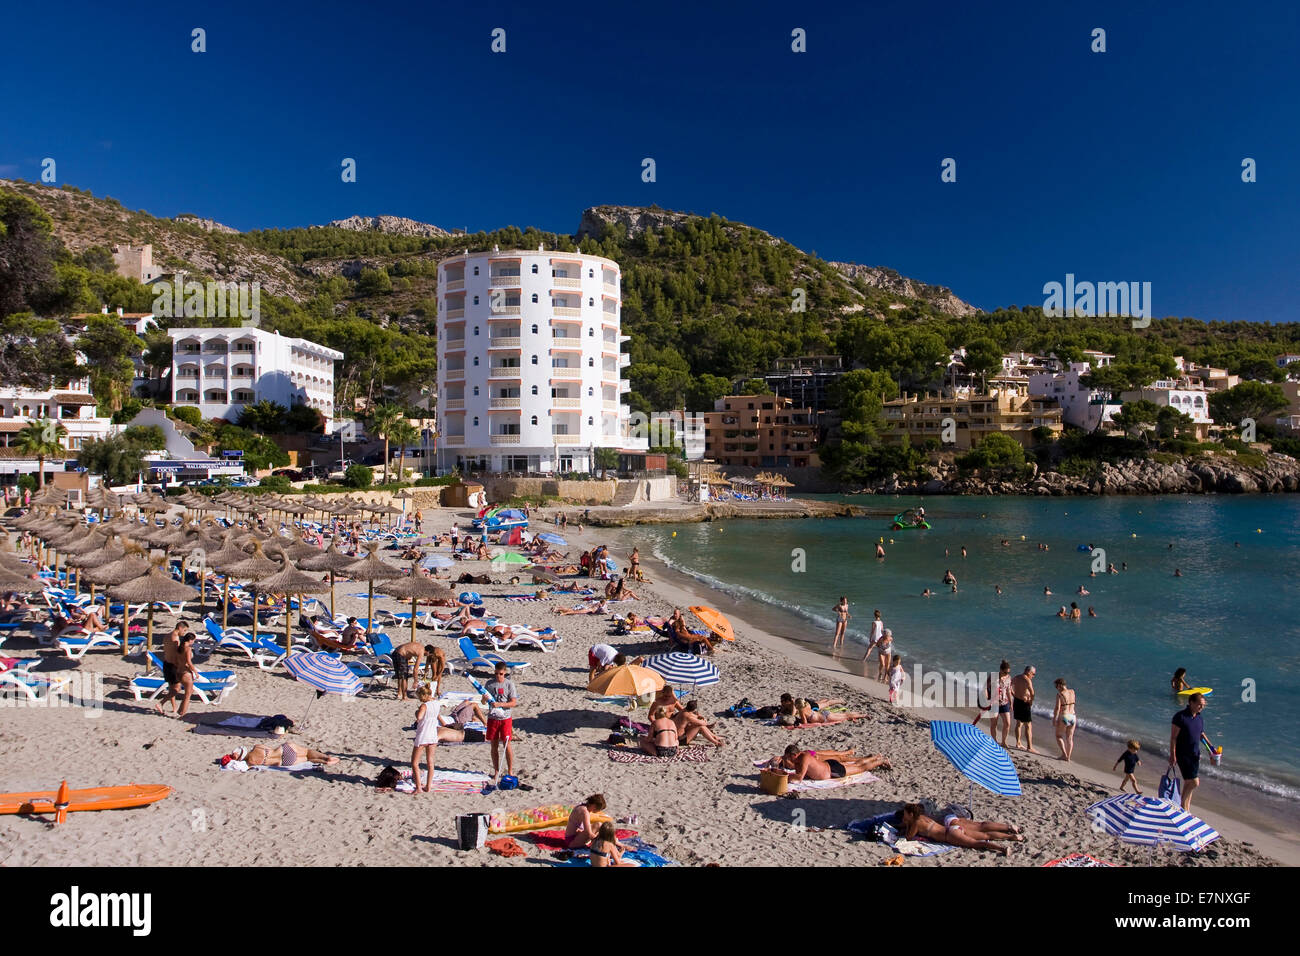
<box><xmin>438</xmin><ymin>248</ymin><xmax>646</xmax><ymax>473</ymax></box>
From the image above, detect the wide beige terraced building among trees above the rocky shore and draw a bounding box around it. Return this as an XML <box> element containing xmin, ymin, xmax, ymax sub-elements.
<box><xmin>883</xmin><ymin>381</ymin><xmax>1063</xmax><ymax>451</ymax></box>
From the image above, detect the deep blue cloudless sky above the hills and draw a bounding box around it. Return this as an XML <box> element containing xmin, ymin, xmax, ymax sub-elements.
<box><xmin>0</xmin><ymin>0</ymin><xmax>1300</xmax><ymax>320</ymax></box>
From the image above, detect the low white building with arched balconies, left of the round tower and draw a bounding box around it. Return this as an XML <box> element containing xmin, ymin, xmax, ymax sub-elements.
<box><xmin>168</xmin><ymin>328</ymin><xmax>343</xmax><ymax>432</ymax></box>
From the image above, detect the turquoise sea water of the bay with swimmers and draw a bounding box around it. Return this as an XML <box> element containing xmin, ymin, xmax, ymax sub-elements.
<box><xmin>621</xmin><ymin>496</ymin><xmax>1300</xmax><ymax>799</ymax></box>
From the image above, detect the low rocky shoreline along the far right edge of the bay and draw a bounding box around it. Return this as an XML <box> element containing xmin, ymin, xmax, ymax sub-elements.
<box><xmin>859</xmin><ymin>455</ymin><xmax>1300</xmax><ymax>496</ymax></box>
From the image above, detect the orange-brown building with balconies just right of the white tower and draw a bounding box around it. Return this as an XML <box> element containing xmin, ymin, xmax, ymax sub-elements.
<box><xmin>701</xmin><ymin>395</ymin><xmax>822</xmax><ymax>468</ymax></box>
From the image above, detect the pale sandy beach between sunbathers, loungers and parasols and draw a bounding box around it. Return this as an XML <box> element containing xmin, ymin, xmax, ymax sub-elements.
<box><xmin>0</xmin><ymin>509</ymin><xmax>1300</xmax><ymax>866</ymax></box>
